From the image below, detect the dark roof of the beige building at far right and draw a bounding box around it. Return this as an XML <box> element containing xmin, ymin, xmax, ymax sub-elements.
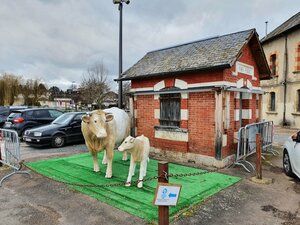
<box><xmin>261</xmin><ymin>12</ymin><xmax>300</xmax><ymax>43</ymax></box>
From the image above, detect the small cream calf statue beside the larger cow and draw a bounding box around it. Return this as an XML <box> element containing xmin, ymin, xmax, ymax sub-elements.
<box><xmin>118</xmin><ymin>135</ymin><xmax>150</xmax><ymax>188</ymax></box>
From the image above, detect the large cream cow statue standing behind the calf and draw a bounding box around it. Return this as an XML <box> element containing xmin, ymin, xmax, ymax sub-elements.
<box><xmin>81</xmin><ymin>107</ymin><xmax>130</xmax><ymax>178</ymax></box>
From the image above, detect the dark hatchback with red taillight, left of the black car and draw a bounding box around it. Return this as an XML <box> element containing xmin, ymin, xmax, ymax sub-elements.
<box><xmin>3</xmin><ymin>108</ymin><xmax>63</xmax><ymax>137</ymax></box>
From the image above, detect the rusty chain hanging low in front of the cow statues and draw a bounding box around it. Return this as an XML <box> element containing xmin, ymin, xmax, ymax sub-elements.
<box><xmin>19</xmin><ymin>161</ymin><xmax>221</xmax><ymax>187</ymax></box>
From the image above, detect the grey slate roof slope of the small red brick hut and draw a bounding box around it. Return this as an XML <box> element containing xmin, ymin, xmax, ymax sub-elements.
<box><xmin>122</xmin><ymin>29</ymin><xmax>255</xmax><ymax>80</ymax></box>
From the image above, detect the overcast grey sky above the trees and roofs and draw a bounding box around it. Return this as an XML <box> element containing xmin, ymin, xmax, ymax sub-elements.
<box><xmin>0</xmin><ymin>0</ymin><xmax>300</xmax><ymax>90</ymax></box>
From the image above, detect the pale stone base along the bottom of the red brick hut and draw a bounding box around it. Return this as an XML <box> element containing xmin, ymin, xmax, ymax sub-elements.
<box><xmin>150</xmin><ymin>148</ymin><xmax>236</xmax><ymax>168</ymax></box>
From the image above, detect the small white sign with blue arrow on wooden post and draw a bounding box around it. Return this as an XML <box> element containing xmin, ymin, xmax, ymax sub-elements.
<box><xmin>153</xmin><ymin>183</ymin><xmax>181</xmax><ymax>206</ymax></box>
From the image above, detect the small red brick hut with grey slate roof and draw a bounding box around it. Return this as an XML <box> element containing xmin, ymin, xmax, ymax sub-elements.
<box><xmin>122</xmin><ymin>29</ymin><xmax>270</xmax><ymax>167</ymax></box>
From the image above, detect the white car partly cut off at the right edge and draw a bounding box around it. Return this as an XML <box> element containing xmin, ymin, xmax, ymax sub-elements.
<box><xmin>283</xmin><ymin>131</ymin><xmax>300</xmax><ymax>178</ymax></box>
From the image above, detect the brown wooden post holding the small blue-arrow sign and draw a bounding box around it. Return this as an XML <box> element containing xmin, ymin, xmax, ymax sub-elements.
<box><xmin>158</xmin><ymin>161</ymin><xmax>169</xmax><ymax>225</ymax></box>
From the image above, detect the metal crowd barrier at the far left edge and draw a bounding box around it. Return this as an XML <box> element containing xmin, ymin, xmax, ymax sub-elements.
<box><xmin>0</xmin><ymin>129</ymin><xmax>31</xmax><ymax>187</ymax></box>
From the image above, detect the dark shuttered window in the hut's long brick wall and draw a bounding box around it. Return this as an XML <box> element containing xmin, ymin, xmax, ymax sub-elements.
<box><xmin>159</xmin><ymin>93</ymin><xmax>181</xmax><ymax>127</ymax></box>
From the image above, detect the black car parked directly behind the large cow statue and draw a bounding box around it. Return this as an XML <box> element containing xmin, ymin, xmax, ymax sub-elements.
<box><xmin>23</xmin><ymin>112</ymin><xmax>85</xmax><ymax>148</ymax></box>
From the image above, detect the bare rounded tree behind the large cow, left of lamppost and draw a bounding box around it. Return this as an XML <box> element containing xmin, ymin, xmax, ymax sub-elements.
<box><xmin>80</xmin><ymin>62</ymin><xmax>110</xmax><ymax>108</ymax></box>
